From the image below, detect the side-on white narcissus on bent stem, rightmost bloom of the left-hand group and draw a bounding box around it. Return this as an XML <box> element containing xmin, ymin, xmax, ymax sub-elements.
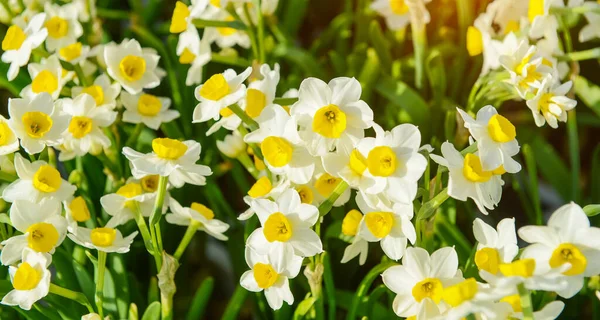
<box><xmin>165</xmin><ymin>198</ymin><xmax>229</xmax><ymax>241</ymax></box>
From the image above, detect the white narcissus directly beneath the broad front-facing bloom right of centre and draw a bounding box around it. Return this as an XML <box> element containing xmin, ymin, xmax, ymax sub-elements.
<box><xmin>356</xmin><ymin>193</ymin><xmax>417</xmax><ymax>260</ymax></box>
